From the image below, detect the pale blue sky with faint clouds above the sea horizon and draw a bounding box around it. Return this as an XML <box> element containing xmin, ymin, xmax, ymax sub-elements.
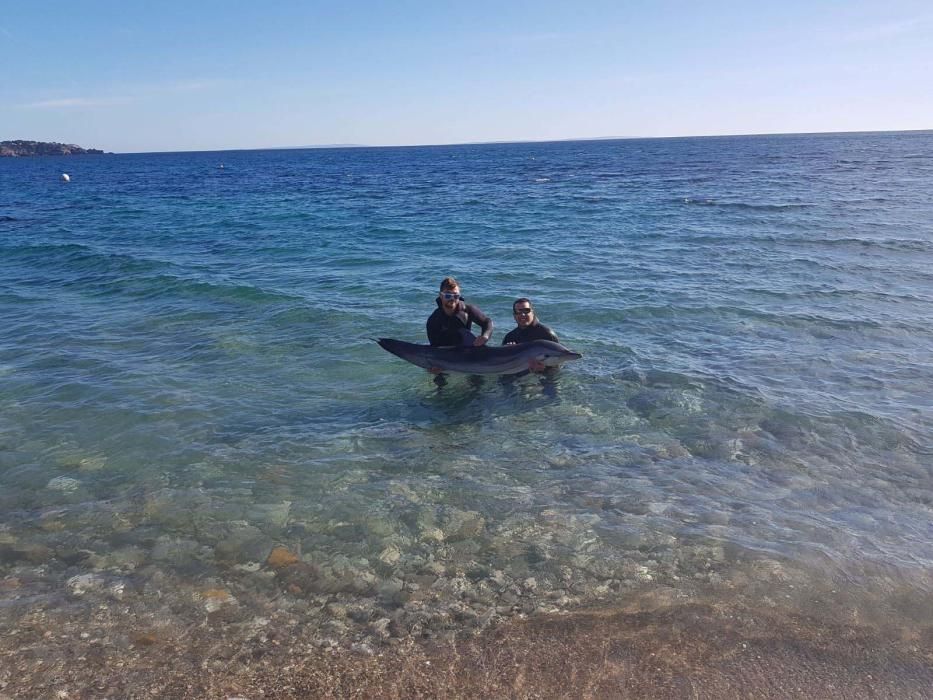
<box><xmin>0</xmin><ymin>0</ymin><xmax>933</xmax><ymax>152</ymax></box>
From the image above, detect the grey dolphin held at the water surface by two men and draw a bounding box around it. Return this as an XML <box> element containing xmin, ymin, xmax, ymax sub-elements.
<box><xmin>376</xmin><ymin>338</ymin><xmax>583</xmax><ymax>374</ymax></box>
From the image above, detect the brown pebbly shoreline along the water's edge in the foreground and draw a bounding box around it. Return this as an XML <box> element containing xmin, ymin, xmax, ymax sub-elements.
<box><xmin>0</xmin><ymin>592</ymin><xmax>933</xmax><ymax>700</ymax></box>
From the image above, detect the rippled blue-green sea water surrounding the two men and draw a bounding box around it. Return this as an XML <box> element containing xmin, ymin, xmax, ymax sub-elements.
<box><xmin>0</xmin><ymin>132</ymin><xmax>933</xmax><ymax>656</ymax></box>
